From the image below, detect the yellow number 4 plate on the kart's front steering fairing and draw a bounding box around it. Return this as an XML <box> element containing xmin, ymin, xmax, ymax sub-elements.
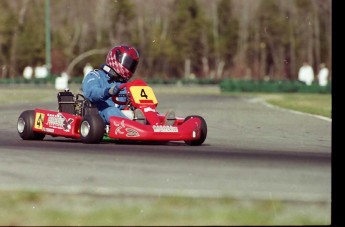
<box><xmin>130</xmin><ymin>86</ymin><xmax>158</xmax><ymax>104</ymax></box>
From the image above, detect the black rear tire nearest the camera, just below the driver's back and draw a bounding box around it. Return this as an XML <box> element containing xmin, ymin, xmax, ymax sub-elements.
<box><xmin>80</xmin><ymin>114</ymin><xmax>105</xmax><ymax>143</ymax></box>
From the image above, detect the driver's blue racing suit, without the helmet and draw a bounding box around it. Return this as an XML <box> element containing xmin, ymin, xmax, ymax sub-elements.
<box><xmin>82</xmin><ymin>69</ymin><xmax>127</xmax><ymax>124</ymax></box>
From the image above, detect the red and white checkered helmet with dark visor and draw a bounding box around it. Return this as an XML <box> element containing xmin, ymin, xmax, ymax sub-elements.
<box><xmin>105</xmin><ymin>45</ymin><xmax>139</xmax><ymax>81</ymax></box>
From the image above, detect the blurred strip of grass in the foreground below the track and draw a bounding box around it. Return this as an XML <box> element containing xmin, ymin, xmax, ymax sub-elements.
<box><xmin>0</xmin><ymin>191</ymin><xmax>331</xmax><ymax>226</ymax></box>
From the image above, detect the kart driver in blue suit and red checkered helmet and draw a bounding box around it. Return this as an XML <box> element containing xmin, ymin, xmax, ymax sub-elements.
<box><xmin>82</xmin><ymin>45</ymin><xmax>146</xmax><ymax>124</ymax></box>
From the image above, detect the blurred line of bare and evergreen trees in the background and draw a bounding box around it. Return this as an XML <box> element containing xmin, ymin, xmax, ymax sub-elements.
<box><xmin>0</xmin><ymin>0</ymin><xmax>332</xmax><ymax>80</ymax></box>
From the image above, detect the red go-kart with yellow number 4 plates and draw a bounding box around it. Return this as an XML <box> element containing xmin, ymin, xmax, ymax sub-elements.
<box><xmin>17</xmin><ymin>80</ymin><xmax>207</xmax><ymax>146</ymax></box>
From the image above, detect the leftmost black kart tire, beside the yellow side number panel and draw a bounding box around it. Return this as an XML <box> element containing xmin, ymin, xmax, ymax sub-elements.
<box><xmin>17</xmin><ymin>110</ymin><xmax>46</xmax><ymax>140</ymax></box>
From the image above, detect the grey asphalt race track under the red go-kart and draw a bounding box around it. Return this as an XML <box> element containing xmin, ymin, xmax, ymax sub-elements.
<box><xmin>0</xmin><ymin>88</ymin><xmax>332</xmax><ymax>202</ymax></box>
